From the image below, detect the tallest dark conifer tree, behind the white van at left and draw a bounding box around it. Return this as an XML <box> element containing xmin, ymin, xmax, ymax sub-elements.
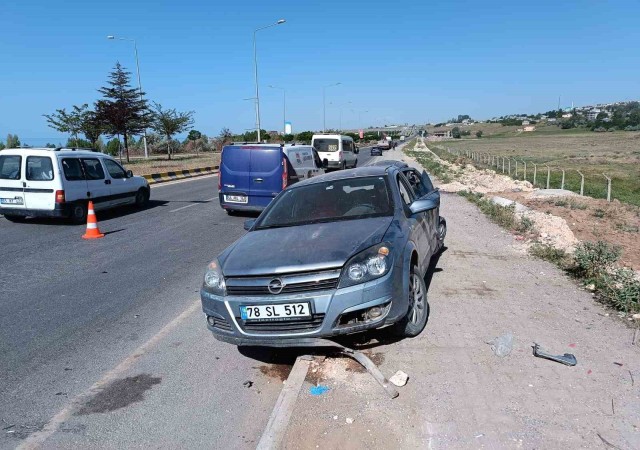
<box><xmin>96</xmin><ymin>62</ymin><xmax>151</xmax><ymax>162</ymax></box>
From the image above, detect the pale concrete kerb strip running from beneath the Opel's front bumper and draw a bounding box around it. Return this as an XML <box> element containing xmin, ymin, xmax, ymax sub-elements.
<box><xmin>256</xmin><ymin>356</ymin><xmax>311</xmax><ymax>450</ymax></box>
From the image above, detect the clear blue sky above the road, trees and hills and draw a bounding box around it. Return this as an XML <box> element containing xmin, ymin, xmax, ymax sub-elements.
<box><xmin>0</xmin><ymin>0</ymin><xmax>640</xmax><ymax>145</ymax></box>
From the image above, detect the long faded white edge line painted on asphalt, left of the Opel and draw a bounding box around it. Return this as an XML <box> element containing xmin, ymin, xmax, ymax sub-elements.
<box><xmin>16</xmin><ymin>300</ymin><xmax>201</xmax><ymax>450</ymax></box>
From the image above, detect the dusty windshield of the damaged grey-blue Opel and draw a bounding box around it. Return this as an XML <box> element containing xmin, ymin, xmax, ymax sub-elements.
<box><xmin>256</xmin><ymin>176</ymin><xmax>393</xmax><ymax>229</ymax></box>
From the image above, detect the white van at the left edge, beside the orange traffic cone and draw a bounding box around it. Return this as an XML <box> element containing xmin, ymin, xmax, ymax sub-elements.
<box><xmin>0</xmin><ymin>148</ymin><xmax>151</xmax><ymax>223</ymax></box>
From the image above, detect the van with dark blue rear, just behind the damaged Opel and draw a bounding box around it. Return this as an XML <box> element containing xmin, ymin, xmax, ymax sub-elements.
<box><xmin>218</xmin><ymin>143</ymin><xmax>326</xmax><ymax>214</ymax></box>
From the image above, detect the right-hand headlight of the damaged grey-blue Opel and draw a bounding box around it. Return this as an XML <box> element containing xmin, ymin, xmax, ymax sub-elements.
<box><xmin>338</xmin><ymin>243</ymin><xmax>391</xmax><ymax>288</ymax></box>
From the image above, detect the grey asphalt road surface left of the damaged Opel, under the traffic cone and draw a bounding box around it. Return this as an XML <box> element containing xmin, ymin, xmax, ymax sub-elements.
<box><xmin>0</xmin><ymin>148</ymin><xmax>378</xmax><ymax>448</ymax></box>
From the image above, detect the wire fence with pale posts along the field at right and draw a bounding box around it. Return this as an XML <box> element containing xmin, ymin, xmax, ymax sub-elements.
<box><xmin>439</xmin><ymin>147</ymin><xmax>620</xmax><ymax>204</ymax></box>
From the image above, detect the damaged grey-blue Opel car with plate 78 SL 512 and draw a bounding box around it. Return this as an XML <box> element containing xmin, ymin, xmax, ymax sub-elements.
<box><xmin>201</xmin><ymin>162</ymin><xmax>446</xmax><ymax>346</ymax></box>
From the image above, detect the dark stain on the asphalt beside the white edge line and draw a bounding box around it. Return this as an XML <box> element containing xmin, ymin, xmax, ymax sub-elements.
<box><xmin>76</xmin><ymin>373</ymin><xmax>162</xmax><ymax>416</ymax></box>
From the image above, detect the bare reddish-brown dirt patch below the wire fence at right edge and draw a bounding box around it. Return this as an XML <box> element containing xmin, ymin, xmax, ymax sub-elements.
<box><xmin>500</xmin><ymin>192</ymin><xmax>640</xmax><ymax>270</ymax></box>
